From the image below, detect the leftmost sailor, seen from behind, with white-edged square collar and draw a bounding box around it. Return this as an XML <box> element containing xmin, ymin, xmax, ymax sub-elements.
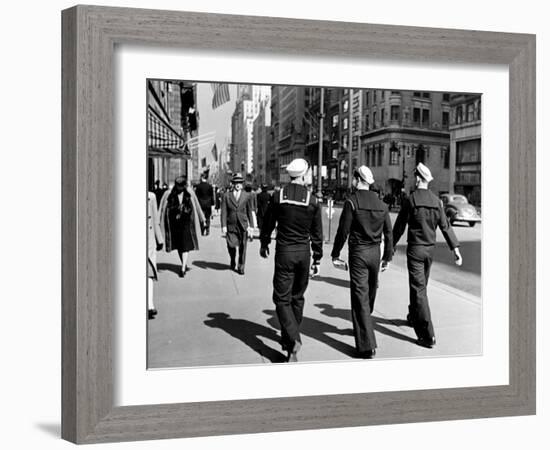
<box><xmin>260</xmin><ymin>158</ymin><xmax>323</xmax><ymax>362</ymax></box>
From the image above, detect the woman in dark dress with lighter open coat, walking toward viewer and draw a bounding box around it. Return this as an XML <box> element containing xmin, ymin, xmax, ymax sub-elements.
<box><xmin>160</xmin><ymin>176</ymin><xmax>205</xmax><ymax>278</ymax></box>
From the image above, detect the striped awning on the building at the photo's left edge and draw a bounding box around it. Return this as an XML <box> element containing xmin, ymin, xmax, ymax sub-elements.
<box><xmin>147</xmin><ymin>106</ymin><xmax>191</xmax><ymax>158</ymax></box>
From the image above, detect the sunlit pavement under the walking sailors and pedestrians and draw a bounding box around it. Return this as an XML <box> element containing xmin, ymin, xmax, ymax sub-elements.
<box><xmin>148</xmin><ymin>209</ymin><xmax>482</xmax><ymax>368</ymax></box>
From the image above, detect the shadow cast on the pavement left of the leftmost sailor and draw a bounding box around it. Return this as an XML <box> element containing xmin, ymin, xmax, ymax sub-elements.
<box><xmin>204</xmin><ymin>312</ymin><xmax>286</xmax><ymax>363</ymax></box>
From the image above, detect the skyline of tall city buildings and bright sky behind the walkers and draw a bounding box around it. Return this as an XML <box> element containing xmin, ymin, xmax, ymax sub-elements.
<box><xmin>147</xmin><ymin>81</ymin><xmax>481</xmax><ymax>206</ymax></box>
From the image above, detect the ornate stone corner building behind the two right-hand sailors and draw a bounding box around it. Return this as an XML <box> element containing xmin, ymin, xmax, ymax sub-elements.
<box><xmin>358</xmin><ymin>89</ymin><xmax>451</xmax><ymax>196</ymax></box>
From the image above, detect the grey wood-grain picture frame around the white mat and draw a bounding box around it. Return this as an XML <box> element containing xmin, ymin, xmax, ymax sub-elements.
<box><xmin>62</xmin><ymin>6</ymin><xmax>535</xmax><ymax>443</ymax></box>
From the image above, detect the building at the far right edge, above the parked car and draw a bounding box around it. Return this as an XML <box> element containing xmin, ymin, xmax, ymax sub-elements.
<box><xmin>449</xmin><ymin>94</ymin><xmax>481</xmax><ymax>206</ymax></box>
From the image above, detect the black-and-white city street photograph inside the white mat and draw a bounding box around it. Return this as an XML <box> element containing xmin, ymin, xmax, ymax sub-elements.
<box><xmin>146</xmin><ymin>79</ymin><xmax>483</xmax><ymax>369</ymax></box>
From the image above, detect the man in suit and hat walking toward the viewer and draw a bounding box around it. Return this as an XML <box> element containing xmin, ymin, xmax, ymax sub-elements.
<box><xmin>221</xmin><ymin>173</ymin><xmax>254</xmax><ymax>275</ymax></box>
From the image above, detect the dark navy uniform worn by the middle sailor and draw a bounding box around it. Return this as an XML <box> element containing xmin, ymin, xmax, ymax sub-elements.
<box><xmin>331</xmin><ymin>190</ymin><xmax>393</xmax><ymax>353</ymax></box>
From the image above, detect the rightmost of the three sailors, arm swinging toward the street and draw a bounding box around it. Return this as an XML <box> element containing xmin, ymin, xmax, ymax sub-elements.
<box><xmin>393</xmin><ymin>163</ymin><xmax>462</xmax><ymax>348</ymax></box>
